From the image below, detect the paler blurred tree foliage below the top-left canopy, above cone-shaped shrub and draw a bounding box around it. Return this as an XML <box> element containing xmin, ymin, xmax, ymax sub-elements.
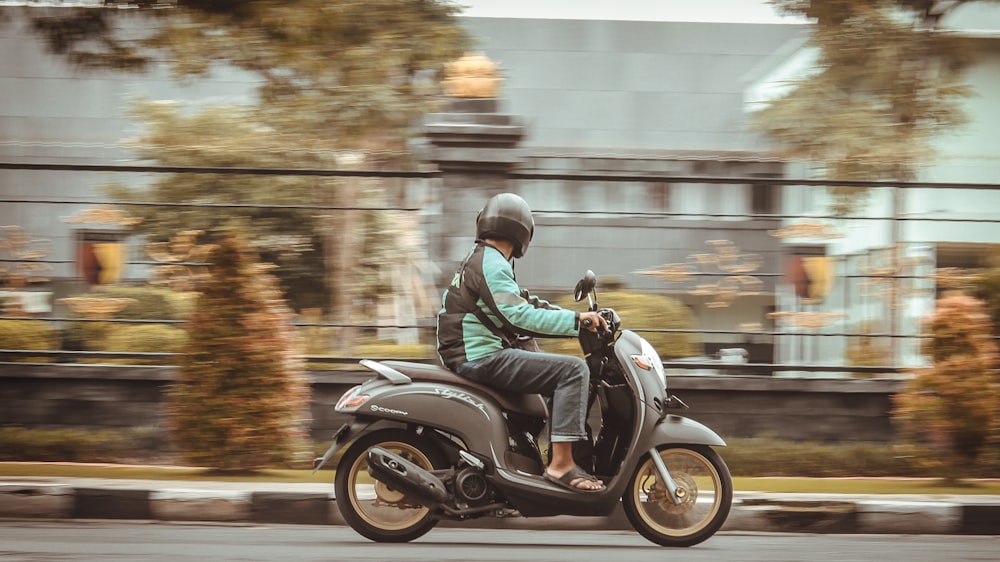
<box><xmin>106</xmin><ymin>102</ymin><xmax>336</xmax><ymax>310</ymax></box>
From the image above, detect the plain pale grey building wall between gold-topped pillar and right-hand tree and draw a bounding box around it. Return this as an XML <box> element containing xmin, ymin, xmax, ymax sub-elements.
<box><xmin>463</xmin><ymin>18</ymin><xmax>808</xmax><ymax>151</ymax></box>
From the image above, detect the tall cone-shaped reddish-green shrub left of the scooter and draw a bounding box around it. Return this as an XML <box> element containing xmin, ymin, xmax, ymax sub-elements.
<box><xmin>167</xmin><ymin>230</ymin><xmax>309</xmax><ymax>471</ymax></box>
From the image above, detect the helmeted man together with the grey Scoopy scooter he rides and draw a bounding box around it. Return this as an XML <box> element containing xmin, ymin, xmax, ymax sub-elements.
<box><xmin>324</xmin><ymin>188</ymin><xmax>733</xmax><ymax>546</ymax></box>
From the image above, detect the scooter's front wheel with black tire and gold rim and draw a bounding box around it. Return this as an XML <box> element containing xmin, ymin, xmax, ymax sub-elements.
<box><xmin>622</xmin><ymin>445</ymin><xmax>733</xmax><ymax>546</ymax></box>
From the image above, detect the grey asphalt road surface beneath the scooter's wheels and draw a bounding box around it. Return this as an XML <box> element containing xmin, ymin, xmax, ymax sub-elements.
<box><xmin>0</xmin><ymin>520</ymin><xmax>1000</xmax><ymax>562</ymax></box>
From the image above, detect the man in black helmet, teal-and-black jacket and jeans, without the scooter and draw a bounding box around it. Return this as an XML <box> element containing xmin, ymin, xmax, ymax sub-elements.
<box><xmin>437</xmin><ymin>193</ymin><xmax>607</xmax><ymax>493</ymax></box>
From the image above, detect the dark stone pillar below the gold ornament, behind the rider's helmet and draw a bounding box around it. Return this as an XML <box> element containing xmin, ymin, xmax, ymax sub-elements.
<box><xmin>424</xmin><ymin>98</ymin><xmax>524</xmax><ymax>287</ymax></box>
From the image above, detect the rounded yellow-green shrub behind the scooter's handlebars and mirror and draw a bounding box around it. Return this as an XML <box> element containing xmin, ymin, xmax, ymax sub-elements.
<box><xmin>540</xmin><ymin>291</ymin><xmax>702</xmax><ymax>360</ymax></box>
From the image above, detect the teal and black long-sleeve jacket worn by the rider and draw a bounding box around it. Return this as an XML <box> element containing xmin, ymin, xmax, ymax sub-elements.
<box><xmin>437</xmin><ymin>238</ymin><xmax>580</xmax><ymax>370</ymax></box>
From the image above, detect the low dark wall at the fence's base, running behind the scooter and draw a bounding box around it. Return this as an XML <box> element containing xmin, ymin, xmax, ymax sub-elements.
<box><xmin>0</xmin><ymin>364</ymin><xmax>902</xmax><ymax>442</ymax></box>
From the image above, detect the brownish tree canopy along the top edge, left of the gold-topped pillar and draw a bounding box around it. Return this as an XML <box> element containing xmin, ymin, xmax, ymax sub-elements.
<box><xmin>27</xmin><ymin>0</ymin><xmax>468</xmax><ymax>148</ymax></box>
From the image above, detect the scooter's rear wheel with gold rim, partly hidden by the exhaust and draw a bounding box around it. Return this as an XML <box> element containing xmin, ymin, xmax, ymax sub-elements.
<box><xmin>334</xmin><ymin>429</ymin><xmax>445</xmax><ymax>542</ymax></box>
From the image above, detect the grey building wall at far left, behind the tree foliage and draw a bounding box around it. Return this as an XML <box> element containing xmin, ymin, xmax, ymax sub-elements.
<box><xmin>0</xmin><ymin>7</ymin><xmax>257</xmax><ymax>279</ymax></box>
